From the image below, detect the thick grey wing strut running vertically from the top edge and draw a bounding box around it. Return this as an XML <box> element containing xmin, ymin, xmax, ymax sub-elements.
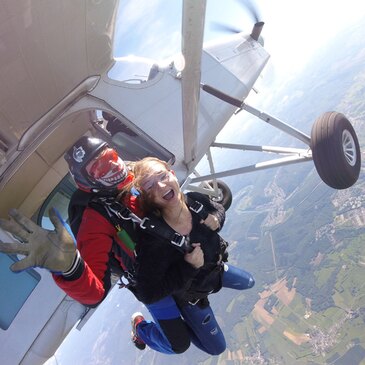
<box><xmin>181</xmin><ymin>0</ymin><xmax>206</xmax><ymax>165</ymax></box>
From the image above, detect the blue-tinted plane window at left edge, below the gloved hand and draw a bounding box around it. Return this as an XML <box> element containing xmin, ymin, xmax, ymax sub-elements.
<box><xmin>0</xmin><ymin>253</ymin><xmax>41</xmax><ymax>330</ymax></box>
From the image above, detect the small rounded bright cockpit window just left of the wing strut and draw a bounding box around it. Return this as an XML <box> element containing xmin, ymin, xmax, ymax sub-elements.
<box><xmin>108</xmin><ymin>56</ymin><xmax>158</xmax><ymax>84</ymax></box>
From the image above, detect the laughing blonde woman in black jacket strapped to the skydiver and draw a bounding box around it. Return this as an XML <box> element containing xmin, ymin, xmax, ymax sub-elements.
<box><xmin>122</xmin><ymin>157</ymin><xmax>255</xmax><ymax>355</ymax></box>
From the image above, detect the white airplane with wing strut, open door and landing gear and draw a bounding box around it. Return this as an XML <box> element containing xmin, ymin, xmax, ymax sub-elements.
<box><xmin>0</xmin><ymin>0</ymin><xmax>360</xmax><ymax>365</ymax></box>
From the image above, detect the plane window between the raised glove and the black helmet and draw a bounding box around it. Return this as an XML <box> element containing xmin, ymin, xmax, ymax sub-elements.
<box><xmin>34</xmin><ymin>174</ymin><xmax>76</xmax><ymax>230</ymax></box>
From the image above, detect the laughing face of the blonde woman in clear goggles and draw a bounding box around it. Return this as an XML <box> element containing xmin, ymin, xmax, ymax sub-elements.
<box><xmin>140</xmin><ymin>161</ymin><xmax>180</xmax><ymax>208</ymax></box>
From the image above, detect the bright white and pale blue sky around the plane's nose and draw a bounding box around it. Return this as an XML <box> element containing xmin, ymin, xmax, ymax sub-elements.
<box><xmin>110</xmin><ymin>0</ymin><xmax>365</xmax><ymax>137</ymax></box>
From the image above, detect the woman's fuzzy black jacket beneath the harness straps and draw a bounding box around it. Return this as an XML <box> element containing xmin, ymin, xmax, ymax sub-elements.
<box><xmin>133</xmin><ymin>193</ymin><xmax>225</xmax><ymax>304</ymax></box>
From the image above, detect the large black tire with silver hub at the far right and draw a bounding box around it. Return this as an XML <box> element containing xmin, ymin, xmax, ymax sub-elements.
<box><xmin>311</xmin><ymin>112</ymin><xmax>361</xmax><ymax>189</ymax></box>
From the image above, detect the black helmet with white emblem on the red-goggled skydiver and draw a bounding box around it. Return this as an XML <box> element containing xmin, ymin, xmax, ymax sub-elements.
<box><xmin>64</xmin><ymin>136</ymin><xmax>108</xmax><ymax>191</ymax></box>
